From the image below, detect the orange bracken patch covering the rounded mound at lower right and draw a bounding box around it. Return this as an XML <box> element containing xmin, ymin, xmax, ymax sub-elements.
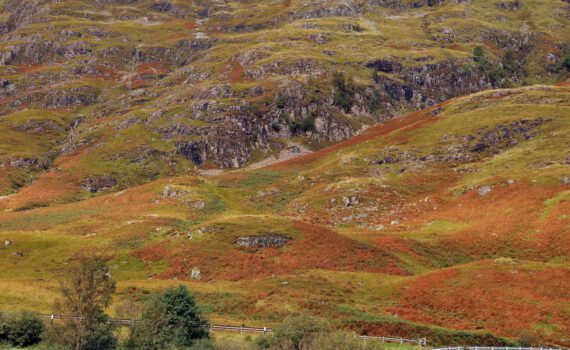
<box><xmin>388</xmin><ymin>261</ymin><xmax>570</xmax><ymax>341</ymax></box>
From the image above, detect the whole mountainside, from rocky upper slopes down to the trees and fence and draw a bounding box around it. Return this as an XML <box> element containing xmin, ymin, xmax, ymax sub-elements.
<box><xmin>0</xmin><ymin>0</ymin><xmax>570</xmax><ymax>346</ymax></box>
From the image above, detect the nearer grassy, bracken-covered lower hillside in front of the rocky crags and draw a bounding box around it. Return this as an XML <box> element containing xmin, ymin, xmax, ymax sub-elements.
<box><xmin>0</xmin><ymin>83</ymin><xmax>570</xmax><ymax>346</ymax></box>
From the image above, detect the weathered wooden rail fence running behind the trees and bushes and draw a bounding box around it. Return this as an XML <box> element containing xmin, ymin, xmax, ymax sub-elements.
<box><xmin>0</xmin><ymin>312</ymin><xmax>426</xmax><ymax>350</ymax></box>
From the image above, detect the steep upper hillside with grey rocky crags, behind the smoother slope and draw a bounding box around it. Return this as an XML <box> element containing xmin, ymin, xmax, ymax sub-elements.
<box><xmin>0</xmin><ymin>0</ymin><xmax>570</xmax><ymax>204</ymax></box>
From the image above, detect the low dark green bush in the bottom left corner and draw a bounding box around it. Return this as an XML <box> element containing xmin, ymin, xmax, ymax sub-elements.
<box><xmin>0</xmin><ymin>313</ymin><xmax>44</xmax><ymax>347</ymax></box>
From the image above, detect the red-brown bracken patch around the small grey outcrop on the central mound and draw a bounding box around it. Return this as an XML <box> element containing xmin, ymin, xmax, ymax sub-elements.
<box><xmin>134</xmin><ymin>221</ymin><xmax>407</xmax><ymax>280</ymax></box>
